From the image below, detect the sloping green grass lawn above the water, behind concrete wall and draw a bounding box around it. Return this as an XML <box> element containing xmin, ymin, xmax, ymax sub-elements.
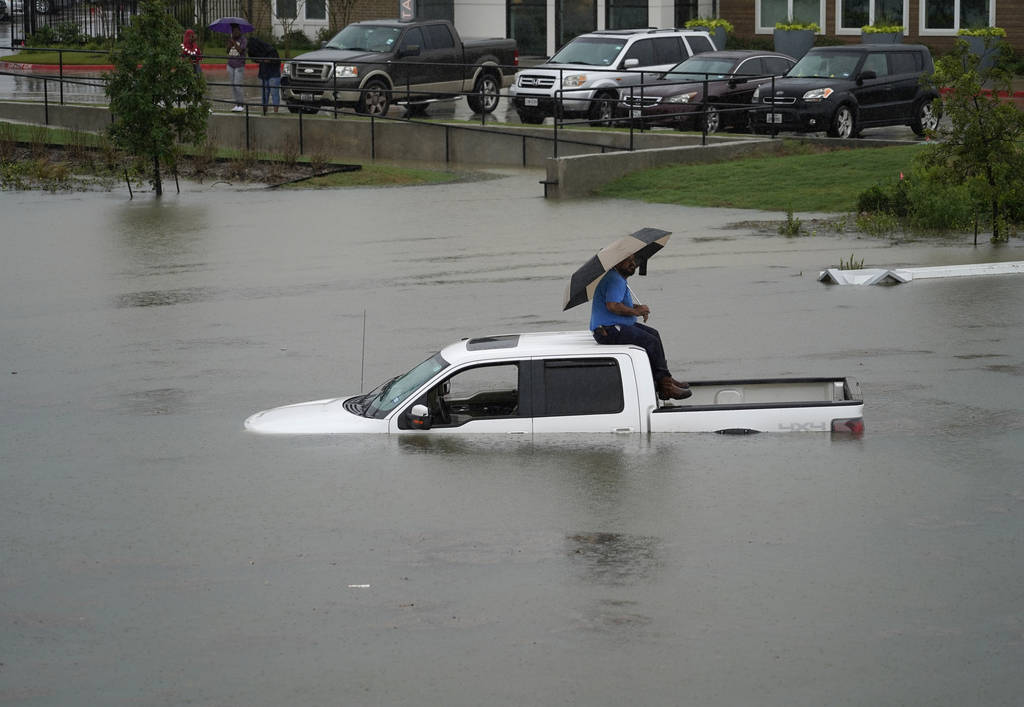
<box><xmin>598</xmin><ymin>142</ymin><xmax>928</xmax><ymax>213</ymax></box>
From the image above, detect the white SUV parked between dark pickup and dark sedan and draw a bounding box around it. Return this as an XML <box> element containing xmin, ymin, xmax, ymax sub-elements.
<box><xmin>509</xmin><ymin>30</ymin><xmax>715</xmax><ymax>125</ymax></box>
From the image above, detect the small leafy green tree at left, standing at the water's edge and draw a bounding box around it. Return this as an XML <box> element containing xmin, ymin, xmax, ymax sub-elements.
<box><xmin>105</xmin><ymin>0</ymin><xmax>210</xmax><ymax>196</ymax></box>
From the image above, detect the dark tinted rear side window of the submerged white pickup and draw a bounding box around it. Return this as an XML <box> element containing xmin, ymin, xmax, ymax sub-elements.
<box><xmin>535</xmin><ymin>359</ymin><xmax>625</xmax><ymax>416</ymax></box>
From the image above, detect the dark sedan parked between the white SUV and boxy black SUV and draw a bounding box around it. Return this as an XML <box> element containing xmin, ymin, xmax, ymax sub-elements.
<box><xmin>620</xmin><ymin>50</ymin><xmax>797</xmax><ymax>133</ymax></box>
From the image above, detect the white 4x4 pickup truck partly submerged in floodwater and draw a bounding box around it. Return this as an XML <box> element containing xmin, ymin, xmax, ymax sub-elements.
<box><xmin>245</xmin><ymin>331</ymin><xmax>864</xmax><ymax>434</ymax></box>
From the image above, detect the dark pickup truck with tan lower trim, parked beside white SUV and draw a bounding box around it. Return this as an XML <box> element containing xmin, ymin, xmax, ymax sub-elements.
<box><xmin>281</xmin><ymin>19</ymin><xmax>519</xmax><ymax>116</ymax></box>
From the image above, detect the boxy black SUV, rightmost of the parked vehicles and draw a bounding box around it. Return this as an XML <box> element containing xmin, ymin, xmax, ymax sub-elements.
<box><xmin>750</xmin><ymin>44</ymin><xmax>939</xmax><ymax>137</ymax></box>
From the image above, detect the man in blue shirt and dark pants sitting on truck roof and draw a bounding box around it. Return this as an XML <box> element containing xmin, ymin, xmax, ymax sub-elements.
<box><xmin>590</xmin><ymin>255</ymin><xmax>693</xmax><ymax>401</ymax></box>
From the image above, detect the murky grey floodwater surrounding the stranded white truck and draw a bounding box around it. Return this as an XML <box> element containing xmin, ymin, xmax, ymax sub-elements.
<box><xmin>0</xmin><ymin>171</ymin><xmax>1024</xmax><ymax>707</ymax></box>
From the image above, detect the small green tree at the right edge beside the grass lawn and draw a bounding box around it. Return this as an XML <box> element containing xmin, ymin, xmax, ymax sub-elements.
<box><xmin>921</xmin><ymin>40</ymin><xmax>1024</xmax><ymax>241</ymax></box>
